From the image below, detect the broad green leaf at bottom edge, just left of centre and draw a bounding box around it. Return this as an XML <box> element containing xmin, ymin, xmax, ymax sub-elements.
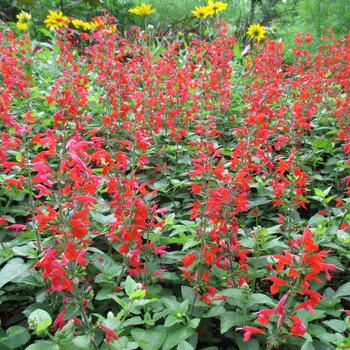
<box><xmin>131</xmin><ymin>326</ymin><xmax>167</xmax><ymax>350</ymax></box>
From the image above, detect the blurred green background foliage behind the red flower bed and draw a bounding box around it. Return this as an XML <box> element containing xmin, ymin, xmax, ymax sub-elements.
<box><xmin>0</xmin><ymin>0</ymin><xmax>350</xmax><ymax>51</ymax></box>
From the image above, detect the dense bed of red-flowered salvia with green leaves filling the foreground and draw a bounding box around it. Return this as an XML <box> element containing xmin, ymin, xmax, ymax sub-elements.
<box><xmin>0</xmin><ymin>15</ymin><xmax>350</xmax><ymax>350</ymax></box>
